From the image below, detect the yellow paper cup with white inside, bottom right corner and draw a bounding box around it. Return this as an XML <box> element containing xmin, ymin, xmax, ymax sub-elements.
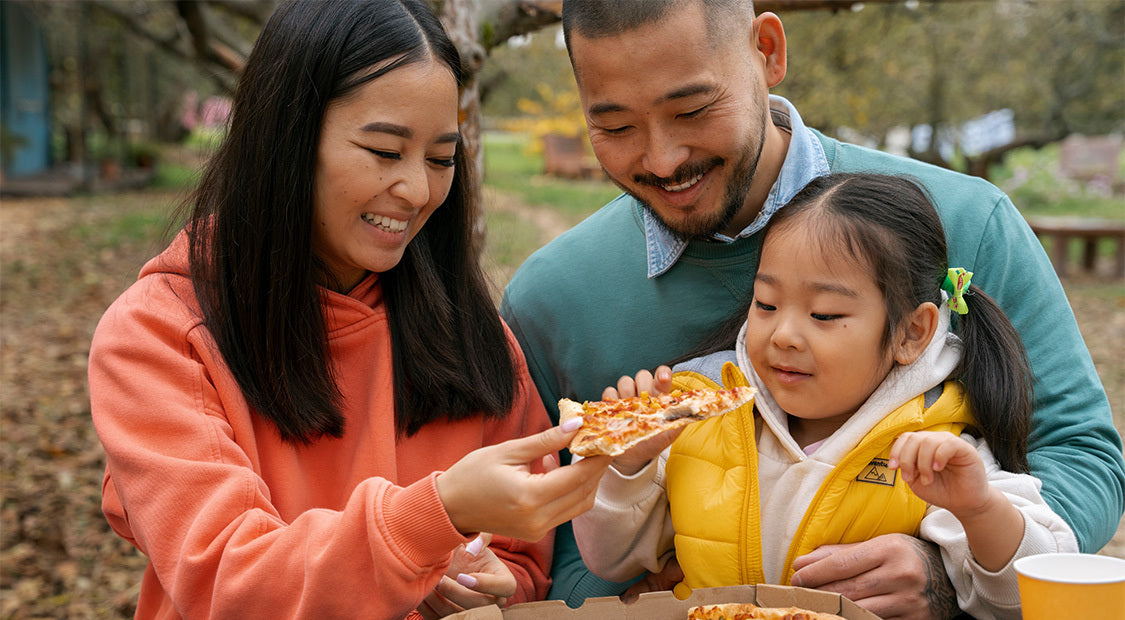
<box><xmin>1015</xmin><ymin>554</ymin><xmax>1125</xmax><ymax>620</ymax></box>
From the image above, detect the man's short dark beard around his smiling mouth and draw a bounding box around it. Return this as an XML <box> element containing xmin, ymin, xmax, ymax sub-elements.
<box><xmin>611</xmin><ymin>140</ymin><xmax>765</xmax><ymax>239</ymax></box>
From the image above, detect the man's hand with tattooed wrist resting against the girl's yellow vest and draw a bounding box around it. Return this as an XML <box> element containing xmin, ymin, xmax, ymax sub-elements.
<box><xmin>792</xmin><ymin>534</ymin><xmax>961</xmax><ymax>620</ymax></box>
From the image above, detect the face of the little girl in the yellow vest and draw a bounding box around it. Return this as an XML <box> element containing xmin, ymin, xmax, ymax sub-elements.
<box><xmin>746</xmin><ymin>218</ymin><xmax>894</xmax><ymax>439</ymax></box>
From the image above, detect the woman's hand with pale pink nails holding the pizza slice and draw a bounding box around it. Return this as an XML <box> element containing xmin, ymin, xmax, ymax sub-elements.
<box><xmin>437</xmin><ymin>417</ymin><xmax>611</xmax><ymax>542</ymax></box>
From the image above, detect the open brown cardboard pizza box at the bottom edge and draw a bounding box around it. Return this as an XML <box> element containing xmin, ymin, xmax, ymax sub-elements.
<box><xmin>449</xmin><ymin>584</ymin><xmax>879</xmax><ymax>620</ymax></box>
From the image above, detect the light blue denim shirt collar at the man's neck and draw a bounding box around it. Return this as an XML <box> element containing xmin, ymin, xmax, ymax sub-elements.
<box><xmin>641</xmin><ymin>95</ymin><xmax>828</xmax><ymax>278</ymax></box>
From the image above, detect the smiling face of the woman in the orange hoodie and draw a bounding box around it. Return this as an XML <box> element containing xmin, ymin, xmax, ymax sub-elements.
<box><xmin>313</xmin><ymin>60</ymin><xmax>460</xmax><ymax>291</ymax></box>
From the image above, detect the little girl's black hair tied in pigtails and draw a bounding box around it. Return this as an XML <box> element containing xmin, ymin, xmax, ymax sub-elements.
<box><xmin>689</xmin><ymin>173</ymin><xmax>1033</xmax><ymax>473</ymax></box>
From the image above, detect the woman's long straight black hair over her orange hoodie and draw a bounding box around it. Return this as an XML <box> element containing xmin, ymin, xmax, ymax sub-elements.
<box><xmin>186</xmin><ymin>0</ymin><xmax>516</xmax><ymax>443</ymax></box>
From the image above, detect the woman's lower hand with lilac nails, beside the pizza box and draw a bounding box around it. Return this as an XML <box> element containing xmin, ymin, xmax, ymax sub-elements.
<box><xmin>419</xmin><ymin>533</ymin><xmax>516</xmax><ymax>620</ymax></box>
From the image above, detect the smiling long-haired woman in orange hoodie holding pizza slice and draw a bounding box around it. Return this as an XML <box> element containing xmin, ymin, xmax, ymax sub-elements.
<box><xmin>90</xmin><ymin>0</ymin><xmax>608</xmax><ymax>618</ymax></box>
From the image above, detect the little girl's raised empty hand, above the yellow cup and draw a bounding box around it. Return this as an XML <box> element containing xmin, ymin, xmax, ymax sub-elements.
<box><xmin>888</xmin><ymin>431</ymin><xmax>991</xmax><ymax>519</ymax></box>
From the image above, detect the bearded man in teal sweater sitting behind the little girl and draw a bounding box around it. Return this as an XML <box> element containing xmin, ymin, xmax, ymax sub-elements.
<box><xmin>501</xmin><ymin>0</ymin><xmax>1125</xmax><ymax>618</ymax></box>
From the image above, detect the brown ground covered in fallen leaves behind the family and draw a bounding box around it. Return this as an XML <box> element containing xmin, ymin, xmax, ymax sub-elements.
<box><xmin>0</xmin><ymin>191</ymin><xmax>1125</xmax><ymax>619</ymax></box>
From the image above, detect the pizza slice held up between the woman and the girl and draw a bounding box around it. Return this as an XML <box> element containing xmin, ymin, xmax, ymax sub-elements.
<box><xmin>559</xmin><ymin>387</ymin><xmax>756</xmax><ymax>457</ymax></box>
